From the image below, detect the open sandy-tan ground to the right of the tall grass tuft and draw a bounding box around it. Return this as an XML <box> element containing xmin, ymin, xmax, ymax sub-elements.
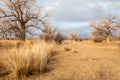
<box><xmin>37</xmin><ymin>42</ymin><xmax>120</xmax><ymax>80</ymax></box>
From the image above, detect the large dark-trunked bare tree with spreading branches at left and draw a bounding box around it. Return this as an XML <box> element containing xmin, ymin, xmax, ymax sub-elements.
<box><xmin>0</xmin><ymin>0</ymin><xmax>47</xmax><ymax>41</ymax></box>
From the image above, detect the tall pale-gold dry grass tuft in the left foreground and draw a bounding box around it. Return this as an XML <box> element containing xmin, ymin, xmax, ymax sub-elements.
<box><xmin>1</xmin><ymin>41</ymin><xmax>53</xmax><ymax>78</ymax></box>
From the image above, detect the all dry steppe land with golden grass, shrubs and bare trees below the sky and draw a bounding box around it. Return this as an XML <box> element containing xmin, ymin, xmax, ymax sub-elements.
<box><xmin>0</xmin><ymin>0</ymin><xmax>120</xmax><ymax>80</ymax></box>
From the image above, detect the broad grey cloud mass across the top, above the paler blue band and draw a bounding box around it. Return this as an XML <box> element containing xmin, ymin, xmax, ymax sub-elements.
<box><xmin>40</xmin><ymin>0</ymin><xmax>120</xmax><ymax>22</ymax></box>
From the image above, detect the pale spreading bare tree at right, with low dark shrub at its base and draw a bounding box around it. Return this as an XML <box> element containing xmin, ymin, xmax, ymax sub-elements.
<box><xmin>90</xmin><ymin>14</ymin><xmax>118</xmax><ymax>43</ymax></box>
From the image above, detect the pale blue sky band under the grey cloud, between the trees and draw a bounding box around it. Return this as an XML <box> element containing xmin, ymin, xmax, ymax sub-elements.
<box><xmin>54</xmin><ymin>22</ymin><xmax>92</xmax><ymax>37</ymax></box>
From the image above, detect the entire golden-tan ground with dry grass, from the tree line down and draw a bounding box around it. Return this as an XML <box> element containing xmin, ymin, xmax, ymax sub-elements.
<box><xmin>0</xmin><ymin>40</ymin><xmax>120</xmax><ymax>80</ymax></box>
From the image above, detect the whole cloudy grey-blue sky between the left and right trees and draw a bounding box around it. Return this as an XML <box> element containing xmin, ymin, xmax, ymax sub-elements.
<box><xmin>38</xmin><ymin>0</ymin><xmax>120</xmax><ymax>37</ymax></box>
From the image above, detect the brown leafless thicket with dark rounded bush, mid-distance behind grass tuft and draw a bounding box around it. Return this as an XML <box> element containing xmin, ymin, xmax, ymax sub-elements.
<box><xmin>40</xmin><ymin>24</ymin><xmax>65</xmax><ymax>44</ymax></box>
